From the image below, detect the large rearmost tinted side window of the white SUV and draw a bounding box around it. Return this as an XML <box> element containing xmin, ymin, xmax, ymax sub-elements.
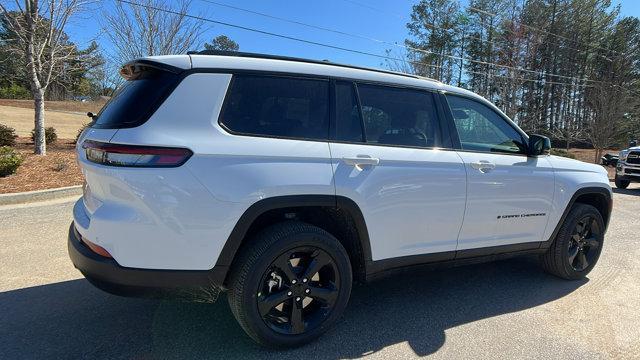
<box><xmin>220</xmin><ymin>75</ymin><xmax>329</xmax><ymax>140</ymax></box>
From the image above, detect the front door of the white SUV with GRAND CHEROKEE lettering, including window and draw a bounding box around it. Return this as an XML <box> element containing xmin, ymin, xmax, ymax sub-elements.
<box><xmin>446</xmin><ymin>94</ymin><xmax>554</xmax><ymax>250</ymax></box>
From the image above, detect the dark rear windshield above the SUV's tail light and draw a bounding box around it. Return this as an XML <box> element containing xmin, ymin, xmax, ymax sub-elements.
<box><xmin>91</xmin><ymin>69</ymin><xmax>177</xmax><ymax>129</ymax></box>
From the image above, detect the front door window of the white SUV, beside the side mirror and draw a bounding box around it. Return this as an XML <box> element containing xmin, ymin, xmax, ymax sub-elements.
<box><xmin>447</xmin><ymin>95</ymin><xmax>526</xmax><ymax>154</ymax></box>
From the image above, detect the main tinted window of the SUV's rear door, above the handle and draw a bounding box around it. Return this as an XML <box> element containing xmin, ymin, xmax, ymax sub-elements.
<box><xmin>358</xmin><ymin>84</ymin><xmax>440</xmax><ymax>147</ymax></box>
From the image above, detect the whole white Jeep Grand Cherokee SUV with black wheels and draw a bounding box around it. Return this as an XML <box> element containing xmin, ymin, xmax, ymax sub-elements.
<box><xmin>68</xmin><ymin>52</ymin><xmax>612</xmax><ymax>347</ymax></box>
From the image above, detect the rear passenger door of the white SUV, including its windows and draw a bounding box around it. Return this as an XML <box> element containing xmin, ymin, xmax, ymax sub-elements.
<box><xmin>330</xmin><ymin>81</ymin><xmax>466</xmax><ymax>262</ymax></box>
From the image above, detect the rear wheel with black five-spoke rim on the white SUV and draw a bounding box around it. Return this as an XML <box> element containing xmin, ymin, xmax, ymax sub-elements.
<box><xmin>227</xmin><ymin>221</ymin><xmax>352</xmax><ymax>348</ymax></box>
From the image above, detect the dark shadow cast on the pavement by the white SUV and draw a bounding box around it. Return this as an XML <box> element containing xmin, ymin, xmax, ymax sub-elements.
<box><xmin>0</xmin><ymin>258</ymin><xmax>587</xmax><ymax>359</ymax></box>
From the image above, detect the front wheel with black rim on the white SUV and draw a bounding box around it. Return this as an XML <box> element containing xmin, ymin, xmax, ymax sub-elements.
<box><xmin>541</xmin><ymin>203</ymin><xmax>605</xmax><ymax>280</ymax></box>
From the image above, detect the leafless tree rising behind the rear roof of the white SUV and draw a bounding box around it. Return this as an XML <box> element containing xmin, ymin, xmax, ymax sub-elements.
<box><xmin>103</xmin><ymin>0</ymin><xmax>204</xmax><ymax>66</ymax></box>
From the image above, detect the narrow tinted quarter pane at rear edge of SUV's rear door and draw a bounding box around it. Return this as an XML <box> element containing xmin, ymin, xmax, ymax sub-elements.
<box><xmin>336</xmin><ymin>81</ymin><xmax>363</xmax><ymax>142</ymax></box>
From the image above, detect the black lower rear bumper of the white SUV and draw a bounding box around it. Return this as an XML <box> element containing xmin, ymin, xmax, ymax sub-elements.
<box><xmin>67</xmin><ymin>223</ymin><xmax>228</xmax><ymax>302</ymax></box>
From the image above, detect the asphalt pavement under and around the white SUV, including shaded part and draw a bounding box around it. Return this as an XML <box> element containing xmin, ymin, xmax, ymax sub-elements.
<box><xmin>0</xmin><ymin>185</ymin><xmax>640</xmax><ymax>359</ymax></box>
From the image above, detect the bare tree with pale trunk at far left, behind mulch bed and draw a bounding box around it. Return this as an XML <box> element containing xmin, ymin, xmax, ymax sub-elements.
<box><xmin>0</xmin><ymin>0</ymin><xmax>86</xmax><ymax>155</ymax></box>
